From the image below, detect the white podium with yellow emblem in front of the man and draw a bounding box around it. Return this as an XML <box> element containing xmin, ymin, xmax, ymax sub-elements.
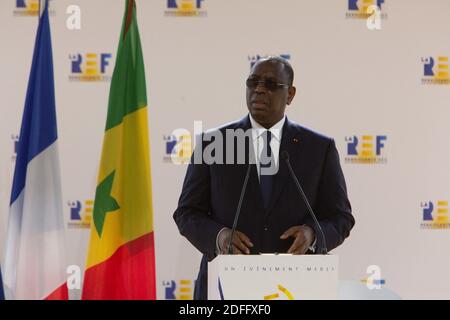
<box><xmin>208</xmin><ymin>254</ymin><xmax>339</xmax><ymax>300</ymax></box>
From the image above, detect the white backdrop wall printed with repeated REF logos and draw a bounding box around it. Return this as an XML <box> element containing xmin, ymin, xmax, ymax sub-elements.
<box><xmin>0</xmin><ymin>0</ymin><xmax>450</xmax><ymax>299</ymax></box>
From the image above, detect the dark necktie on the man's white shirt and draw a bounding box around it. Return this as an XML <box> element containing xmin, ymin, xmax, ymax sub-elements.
<box><xmin>259</xmin><ymin>130</ymin><xmax>275</xmax><ymax>208</ymax></box>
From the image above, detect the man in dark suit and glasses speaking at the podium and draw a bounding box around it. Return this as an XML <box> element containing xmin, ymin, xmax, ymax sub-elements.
<box><xmin>174</xmin><ymin>57</ymin><xmax>355</xmax><ymax>299</ymax></box>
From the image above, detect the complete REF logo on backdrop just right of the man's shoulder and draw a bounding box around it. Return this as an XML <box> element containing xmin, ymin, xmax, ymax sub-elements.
<box><xmin>345</xmin><ymin>135</ymin><xmax>387</xmax><ymax>164</ymax></box>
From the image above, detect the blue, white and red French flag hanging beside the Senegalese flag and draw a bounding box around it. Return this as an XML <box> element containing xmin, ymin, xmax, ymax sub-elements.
<box><xmin>3</xmin><ymin>1</ymin><xmax>68</xmax><ymax>300</ymax></box>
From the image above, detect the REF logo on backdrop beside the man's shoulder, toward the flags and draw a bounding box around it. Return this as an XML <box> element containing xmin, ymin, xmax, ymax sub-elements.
<box><xmin>164</xmin><ymin>129</ymin><xmax>193</xmax><ymax>164</ymax></box>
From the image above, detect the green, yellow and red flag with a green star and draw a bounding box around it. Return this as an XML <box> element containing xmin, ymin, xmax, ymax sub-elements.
<box><xmin>82</xmin><ymin>0</ymin><xmax>156</xmax><ymax>299</ymax></box>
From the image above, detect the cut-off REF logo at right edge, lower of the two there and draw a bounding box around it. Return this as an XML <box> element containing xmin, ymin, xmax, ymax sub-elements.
<box><xmin>420</xmin><ymin>200</ymin><xmax>450</xmax><ymax>229</ymax></box>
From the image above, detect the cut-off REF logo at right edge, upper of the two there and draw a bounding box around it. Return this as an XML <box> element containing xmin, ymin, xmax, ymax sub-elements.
<box><xmin>422</xmin><ymin>56</ymin><xmax>450</xmax><ymax>84</ymax></box>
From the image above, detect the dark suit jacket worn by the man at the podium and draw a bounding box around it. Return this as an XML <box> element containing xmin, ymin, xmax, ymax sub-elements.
<box><xmin>174</xmin><ymin>116</ymin><xmax>355</xmax><ymax>299</ymax></box>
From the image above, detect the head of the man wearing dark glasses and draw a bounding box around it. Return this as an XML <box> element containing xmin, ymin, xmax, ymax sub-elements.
<box><xmin>247</xmin><ymin>57</ymin><xmax>295</xmax><ymax>129</ymax></box>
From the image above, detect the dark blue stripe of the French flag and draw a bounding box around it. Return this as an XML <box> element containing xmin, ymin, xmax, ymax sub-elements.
<box><xmin>11</xmin><ymin>1</ymin><xmax>58</xmax><ymax>204</ymax></box>
